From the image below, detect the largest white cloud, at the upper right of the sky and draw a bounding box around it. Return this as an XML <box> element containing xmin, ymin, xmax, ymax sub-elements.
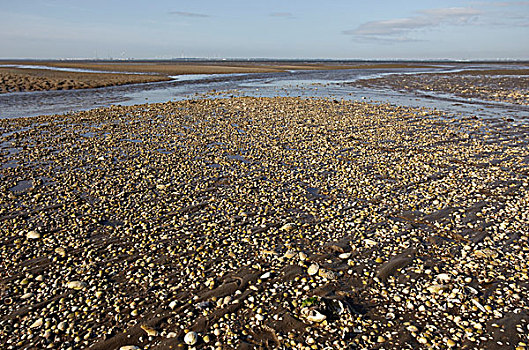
<box><xmin>343</xmin><ymin>7</ymin><xmax>482</xmax><ymax>41</ymax></box>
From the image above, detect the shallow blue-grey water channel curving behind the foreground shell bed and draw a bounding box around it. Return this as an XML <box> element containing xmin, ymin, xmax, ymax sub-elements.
<box><xmin>0</xmin><ymin>64</ymin><xmax>529</xmax><ymax>124</ymax></box>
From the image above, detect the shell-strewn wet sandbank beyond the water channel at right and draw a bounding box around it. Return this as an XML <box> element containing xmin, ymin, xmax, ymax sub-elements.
<box><xmin>354</xmin><ymin>69</ymin><xmax>529</xmax><ymax>105</ymax></box>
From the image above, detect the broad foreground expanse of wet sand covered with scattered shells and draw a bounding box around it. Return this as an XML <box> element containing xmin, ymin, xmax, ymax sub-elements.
<box><xmin>0</xmin><ymin>98</ymin><xmax>529</xmax><ymax>349</ymax></box>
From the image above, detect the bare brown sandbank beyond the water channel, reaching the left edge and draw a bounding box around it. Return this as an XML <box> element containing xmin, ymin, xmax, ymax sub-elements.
<box><xmin>0</xmin><ymin>61</ymin><xmax>440</xmax><ymax>93</ymax></box>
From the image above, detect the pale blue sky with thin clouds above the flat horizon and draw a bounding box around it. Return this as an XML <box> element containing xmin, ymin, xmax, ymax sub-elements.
<box><xmin>0</xmin><ymin>0</ymin><xmax>529</xmax><ymax>60</ymax></box>
